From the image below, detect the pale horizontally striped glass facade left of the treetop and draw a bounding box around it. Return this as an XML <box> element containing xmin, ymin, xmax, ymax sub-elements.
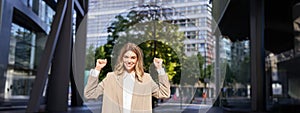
<box><xmin>87</xmin><ymin>0</ymin><xmax>139</xmax><ymax>47</ymax></box>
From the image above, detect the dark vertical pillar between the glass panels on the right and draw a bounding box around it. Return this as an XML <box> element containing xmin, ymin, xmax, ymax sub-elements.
<box><xmin>250</xmin><ymin>0</ymin><xmax>266</xmax><ymax>112</ymax></box>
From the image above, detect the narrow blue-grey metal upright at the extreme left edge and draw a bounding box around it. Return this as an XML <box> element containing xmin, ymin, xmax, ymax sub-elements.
<box><xmin>0</xmin><ymin>0</ymin><xmax>13</xmax><ymax>103</ymax></box>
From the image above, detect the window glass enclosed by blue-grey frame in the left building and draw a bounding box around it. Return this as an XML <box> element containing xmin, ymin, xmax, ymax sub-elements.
<box><xmin>5</xmin><ymin>24</ymin><xmax>46</xmax><ymax>99</ymax></box>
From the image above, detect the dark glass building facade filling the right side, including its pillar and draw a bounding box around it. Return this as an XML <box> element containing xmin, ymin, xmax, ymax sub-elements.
<box><xmin>213</xmin><ymin>0</ymin><xmax>300</xmax><ymax>113</ymax></box>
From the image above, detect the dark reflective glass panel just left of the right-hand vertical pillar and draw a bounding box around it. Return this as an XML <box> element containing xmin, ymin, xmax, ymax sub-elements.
<box><xmin>219</xmin><ymin>36</ymin><xmax>251</xmax><ymax>109</ymax></box>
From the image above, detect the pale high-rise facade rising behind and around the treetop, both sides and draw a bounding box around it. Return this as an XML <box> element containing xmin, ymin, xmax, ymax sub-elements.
<box><xmin>87</xmin><ymin>0</ymin><xmax>214</xmax><ymax>64</ymax></box>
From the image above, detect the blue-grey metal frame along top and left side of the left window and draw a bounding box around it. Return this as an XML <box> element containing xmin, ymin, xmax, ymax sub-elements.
<box><xmin>0</xmin><ymin>0</ymin><xmax>53</xmax><ymax>101</ymax></box>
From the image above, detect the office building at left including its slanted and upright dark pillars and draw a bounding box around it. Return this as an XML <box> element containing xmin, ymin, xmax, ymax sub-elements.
<box><xmin>0</xmin><ymin>0</ymin><xmax>87</xmax><ymax>112</ymax></box>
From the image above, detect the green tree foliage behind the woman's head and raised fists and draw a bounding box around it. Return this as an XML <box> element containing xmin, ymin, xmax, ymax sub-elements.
<box><xmin>96</xmin><ymin>5</ymin><xmax>212</xmax><ymax>84</ymax></box>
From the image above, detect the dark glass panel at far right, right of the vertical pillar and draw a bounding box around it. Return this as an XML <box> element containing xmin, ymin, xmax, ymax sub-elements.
<box><xmin>265</xmin><ymin>3</ymin><xmax>300</xmax><ymax>112</ymax></box>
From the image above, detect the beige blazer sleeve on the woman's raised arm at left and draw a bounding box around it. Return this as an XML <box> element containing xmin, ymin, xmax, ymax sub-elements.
<box><xmin>84</xmin><ymin>75</ymin><xmax>107</xmax><ymax>99</ymax></box>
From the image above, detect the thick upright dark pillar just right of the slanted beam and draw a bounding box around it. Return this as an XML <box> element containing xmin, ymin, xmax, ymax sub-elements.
<box><xmin>47</xmin><ymin>0</ymin><xmax>74</xmax><ymax>112</ymax></box>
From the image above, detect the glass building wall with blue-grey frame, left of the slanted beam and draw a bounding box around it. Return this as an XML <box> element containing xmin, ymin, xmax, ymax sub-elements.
<box><xmin>0</xmin><ymin>0</ymin><xmax>55</xmax><ymax>101</ymax></box>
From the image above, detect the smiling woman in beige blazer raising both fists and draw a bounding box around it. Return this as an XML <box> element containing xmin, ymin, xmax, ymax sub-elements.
<box><xmin>84</xmin><ymin>43</ymin><xmax>170</xmax><ymax>113</ymax></box>
